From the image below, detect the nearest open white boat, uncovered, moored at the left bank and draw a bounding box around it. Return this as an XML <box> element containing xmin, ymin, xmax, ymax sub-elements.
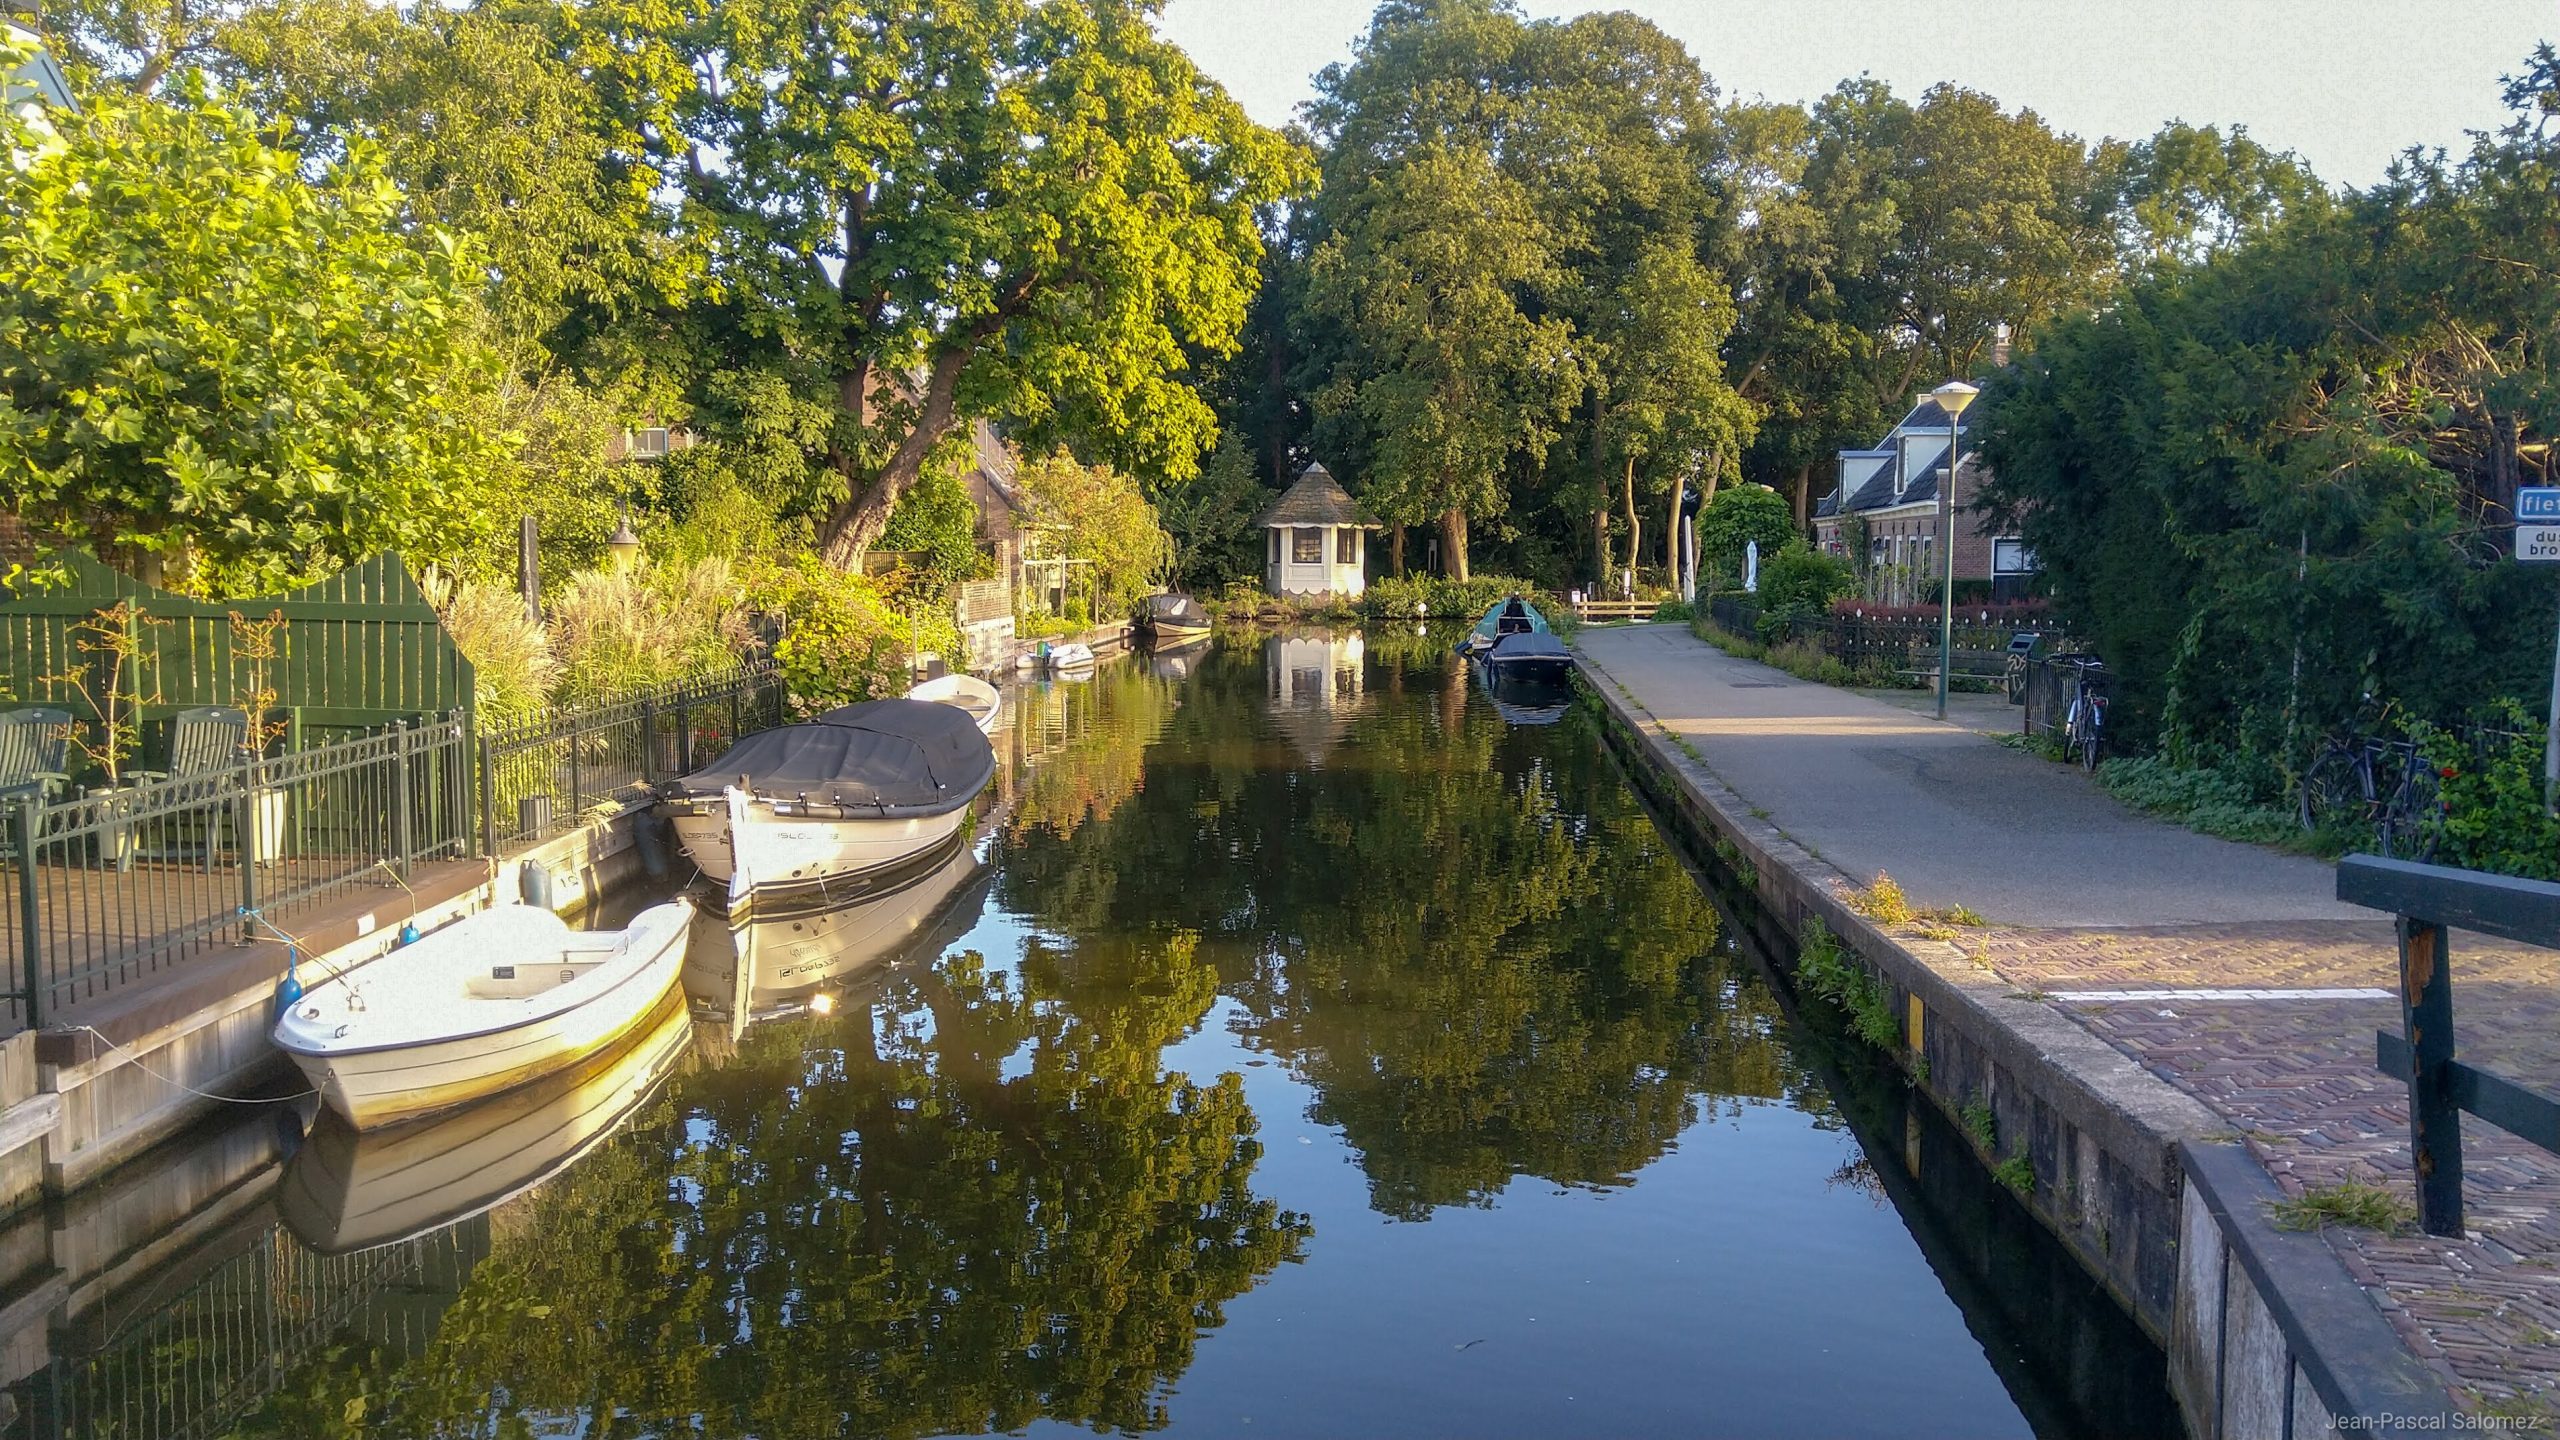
<box><xmin>276</xmin><ymin>899</ymin><xmax>694</xmax><ymax>1130</ymax></box>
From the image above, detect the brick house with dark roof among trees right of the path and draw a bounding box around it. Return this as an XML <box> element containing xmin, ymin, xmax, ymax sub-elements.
<box><xmin>1812</xmin><ymin>395</ymin><xmax>2035</xmax><ymax>605</ymax></box>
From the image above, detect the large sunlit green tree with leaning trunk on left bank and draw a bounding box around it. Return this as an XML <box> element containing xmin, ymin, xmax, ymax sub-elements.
<box><xmin>573</xmin><ymin>0</ymin><xmax>1306</xmax><ymax>564</ymax></box>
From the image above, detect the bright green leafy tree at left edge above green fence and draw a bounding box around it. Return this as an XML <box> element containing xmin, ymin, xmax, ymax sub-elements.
<box><xmin>0</xmin><ymin>79</ymin><xmax>515</xmax><ymax>597</ymax></box>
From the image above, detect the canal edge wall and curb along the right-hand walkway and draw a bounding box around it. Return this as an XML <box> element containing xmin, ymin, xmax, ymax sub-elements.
<box><xmin>1574</xmin><ymin>646</ymin><xmax>2460</xmax><ymax>1440</ymax></box>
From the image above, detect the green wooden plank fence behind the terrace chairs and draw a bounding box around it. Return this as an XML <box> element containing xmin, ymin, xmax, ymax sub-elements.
<box><xmin>0</xmin><ymin>543</ymin><xmax>471</xmax><ymax>753</ymax></box>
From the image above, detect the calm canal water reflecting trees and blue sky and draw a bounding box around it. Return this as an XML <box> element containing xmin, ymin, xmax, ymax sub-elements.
<box><xmin>20</xmin><ymin>628</ymin><xmax>2179</xmax><ymax>1440</ymax></box>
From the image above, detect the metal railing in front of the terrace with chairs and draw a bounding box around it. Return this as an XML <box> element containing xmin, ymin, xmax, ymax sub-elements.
<box><xmin>0</xmin><ymin>715</ymin><xmax>471</xmax><ymax>1030</ymax></box>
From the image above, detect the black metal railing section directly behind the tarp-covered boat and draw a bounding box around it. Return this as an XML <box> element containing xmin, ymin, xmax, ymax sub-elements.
<box><xmin>479</xmin><ymin>661</ymin><xmax>783</xmax><ymax>856</ymax></box>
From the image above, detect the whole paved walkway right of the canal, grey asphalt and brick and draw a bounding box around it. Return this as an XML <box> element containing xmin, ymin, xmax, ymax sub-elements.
<box><xmin>1577</xmin><ymin>625</ymin><xmax>2560</xmax><ymax>1425</ymax></box>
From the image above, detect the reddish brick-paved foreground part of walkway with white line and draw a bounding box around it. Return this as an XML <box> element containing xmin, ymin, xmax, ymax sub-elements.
<box><xmin>1958</xmin><ymin>920</ymin><xmax>2560</xmax><ymax>1414</ymax></box>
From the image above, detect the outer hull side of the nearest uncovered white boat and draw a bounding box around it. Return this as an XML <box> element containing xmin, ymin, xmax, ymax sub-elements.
<box><xmin>279</xmin><ymin>901</ymin><xmax>686</xmax><ymax>1130</ymax></box>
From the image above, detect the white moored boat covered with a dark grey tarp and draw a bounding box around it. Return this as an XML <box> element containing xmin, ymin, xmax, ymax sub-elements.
<box><xmin>658</xmin><ymin>700</ymin><xmax>996</xmax><ymax>894</ymax></box>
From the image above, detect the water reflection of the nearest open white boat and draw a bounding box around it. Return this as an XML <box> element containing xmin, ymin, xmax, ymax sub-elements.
<box><xmin>276</xmin><ymin>994</ymin><xmax>694</xmax><ymax>1256</ymax></box>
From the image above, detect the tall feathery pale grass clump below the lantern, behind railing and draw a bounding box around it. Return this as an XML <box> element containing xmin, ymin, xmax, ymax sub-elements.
<box><xmin>550</xmin><ymin>559</ymin><xmax>750</xmax><ymax>702</ymax></box>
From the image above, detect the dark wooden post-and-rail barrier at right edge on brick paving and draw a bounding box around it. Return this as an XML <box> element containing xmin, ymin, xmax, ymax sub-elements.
<box><xmin>2337</xmin><ymin>856</ymin><xmax>2560</xmax><ymax>1235</ymax></box>
